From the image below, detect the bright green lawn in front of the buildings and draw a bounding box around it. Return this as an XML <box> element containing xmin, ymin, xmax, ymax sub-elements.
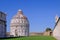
<box><xmin>0</xmin><ymin>36</ymin><xmax>56</xmax><ymax>40</ymax></box>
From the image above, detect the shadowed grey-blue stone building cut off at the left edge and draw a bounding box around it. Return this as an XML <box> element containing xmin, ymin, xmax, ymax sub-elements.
<box><xmin>0</xmin><ymin>11</ymin><xmax>6</xmax><ymax>37</ymax></box>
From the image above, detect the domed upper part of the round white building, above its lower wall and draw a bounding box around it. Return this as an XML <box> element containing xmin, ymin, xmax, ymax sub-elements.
<box><xmin>11</xmin><ymin>10</ymin><xmax>28</xmax><ymax>25</ymax></box>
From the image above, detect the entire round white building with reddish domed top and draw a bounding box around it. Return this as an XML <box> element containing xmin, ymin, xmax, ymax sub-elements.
<box><xmin>10</xmin><ymin>10</ymin><xmax>29</xmax><ymax>37</ymax></box>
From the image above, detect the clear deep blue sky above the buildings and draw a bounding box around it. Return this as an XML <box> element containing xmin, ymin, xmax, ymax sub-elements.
<box><xmin>0</xmin><ymin>0</ymin><xmax>60</xmax><ymax>32</ymax></box>
